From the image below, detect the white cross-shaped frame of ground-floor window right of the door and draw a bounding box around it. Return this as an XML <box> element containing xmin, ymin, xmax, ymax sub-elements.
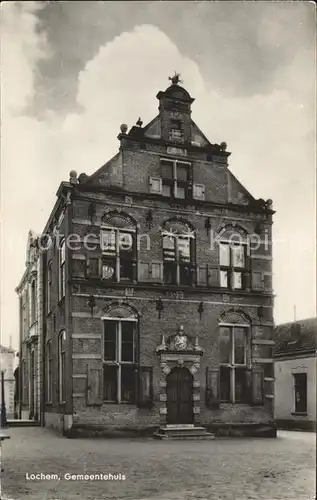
<box><xmin>219</xmin><ymin>323</ymin><xmax>251</xmax><ymax>404</ymax></box>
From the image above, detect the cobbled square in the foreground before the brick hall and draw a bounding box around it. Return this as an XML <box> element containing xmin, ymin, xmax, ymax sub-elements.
<box><xmin>3</xmin><ymin>428</ymin><xmax>316</xmax><ymax>500</ymax></box>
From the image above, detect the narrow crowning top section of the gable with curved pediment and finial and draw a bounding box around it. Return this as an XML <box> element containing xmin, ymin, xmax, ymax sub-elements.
<box><xmin>156</xmin><ymin>74</ymin><xmax>195</xmax><ymax>144</ymax></box>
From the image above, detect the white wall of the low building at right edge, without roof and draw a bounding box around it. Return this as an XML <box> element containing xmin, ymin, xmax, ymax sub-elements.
<box><xmin>274</xmin><ymin>357</ymin><xmax>316</xmax><ymax>422</ymax></box>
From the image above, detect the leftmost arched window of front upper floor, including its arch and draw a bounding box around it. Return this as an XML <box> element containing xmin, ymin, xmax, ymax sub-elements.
<box><xmin>100</xmin><ymin>212</ymin><xmax>137</xmax><ymax>282</ymax></box>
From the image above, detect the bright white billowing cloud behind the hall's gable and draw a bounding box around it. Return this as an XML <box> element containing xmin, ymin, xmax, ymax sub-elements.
<box><xmin>1</xmin><ymin>2</ymin><xmax>315</xmax><ymax>348</ymax></box>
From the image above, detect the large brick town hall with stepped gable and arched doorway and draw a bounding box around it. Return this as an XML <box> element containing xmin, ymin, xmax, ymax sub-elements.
<box><xmin>17</xmin><ymin>76</ymin><xmax>275</xmax><ymax>435</ymax></box>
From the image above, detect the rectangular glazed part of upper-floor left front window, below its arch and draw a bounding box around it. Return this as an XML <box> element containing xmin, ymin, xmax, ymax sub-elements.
<box><xmin>101</xmin><ymin>227</ymin><xmax>136</xmax><ymax>282</ymax></box>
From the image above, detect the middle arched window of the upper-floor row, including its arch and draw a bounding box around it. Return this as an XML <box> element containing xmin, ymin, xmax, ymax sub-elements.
<box><xmin>162</xmin><ymin>220</ymin><xmax>195</xmax><ymax>285</ymax></box>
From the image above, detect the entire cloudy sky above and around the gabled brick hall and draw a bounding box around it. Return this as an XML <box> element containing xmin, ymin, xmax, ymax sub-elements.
<box><xmin>0</xmin><ymin>1</ymin><xmax>316</xmax><ymax>348</ymax></box>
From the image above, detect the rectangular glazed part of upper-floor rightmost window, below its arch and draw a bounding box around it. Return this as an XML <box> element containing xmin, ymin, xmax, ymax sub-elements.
<box><xmin>219</xmin><ymin>241</ymin><xmax>247</xmax><ymax>290</ymax></box>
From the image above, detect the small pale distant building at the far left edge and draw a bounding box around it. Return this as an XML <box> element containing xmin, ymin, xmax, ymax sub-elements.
<box><xmin>0</xmin><ymin>345</ymin><xmax>15</xmax><ymax>419</ymax></box>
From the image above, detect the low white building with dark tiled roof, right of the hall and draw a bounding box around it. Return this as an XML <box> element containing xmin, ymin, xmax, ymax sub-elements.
<box><xmin>274</xmin><ymin>318</ymin><xmax>317</xmax><ymax>430</ymax></box>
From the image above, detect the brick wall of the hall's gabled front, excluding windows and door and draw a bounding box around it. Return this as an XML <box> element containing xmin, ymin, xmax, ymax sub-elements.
<box><xmin>37</xmin><ymin>82</ymin><xmax>273</xmax><ymax>434</ymax></box>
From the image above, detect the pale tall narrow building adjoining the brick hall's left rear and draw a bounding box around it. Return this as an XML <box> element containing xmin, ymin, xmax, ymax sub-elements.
<box><xmin>15</xmin><ymin>231</ymin><xmax>43</xmax><ymax>420</ymax></box>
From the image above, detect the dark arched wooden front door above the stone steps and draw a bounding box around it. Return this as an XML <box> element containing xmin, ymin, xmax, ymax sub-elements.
<box><xmin>166</xmin><ymin>368</ymin><xmax>194</xmax><ymax>424</ymax></box>
